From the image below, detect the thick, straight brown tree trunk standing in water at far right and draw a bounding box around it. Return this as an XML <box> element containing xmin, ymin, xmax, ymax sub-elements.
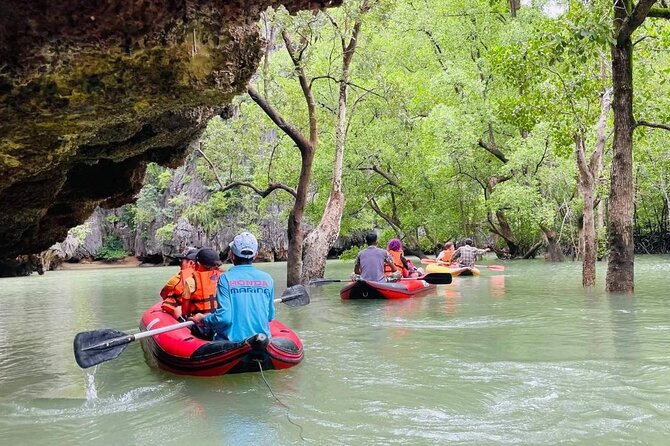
<box><xmin>606</xmin><ymin>38</ymin><xmax>635</xmax><ymax>293</ymax></box>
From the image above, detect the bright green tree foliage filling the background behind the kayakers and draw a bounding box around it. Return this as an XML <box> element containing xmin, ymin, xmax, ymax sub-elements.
<box><xmin>111</xmin><ymin>0</ymin><xmax>670</xmax><ymax>258</ymax></box>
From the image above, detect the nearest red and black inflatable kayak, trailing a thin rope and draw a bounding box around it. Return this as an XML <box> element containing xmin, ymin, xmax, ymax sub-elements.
<box><xmin>140</xmin><ymin>302</ymin><xmax>304</xmax><ymax>376</ymax></box>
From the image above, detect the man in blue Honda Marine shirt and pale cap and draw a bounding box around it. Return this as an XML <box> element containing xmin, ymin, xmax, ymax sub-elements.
<box><xmin>190</xmin><ymin>232</ymin><xmax>275</xmax><ymax>342</ymax></box>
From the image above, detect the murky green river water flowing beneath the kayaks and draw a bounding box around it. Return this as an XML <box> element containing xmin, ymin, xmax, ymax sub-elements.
<box><xmin>0</xmin><ymin>256</ymin><xmax>670</xmax><ymax>446</ymax></box>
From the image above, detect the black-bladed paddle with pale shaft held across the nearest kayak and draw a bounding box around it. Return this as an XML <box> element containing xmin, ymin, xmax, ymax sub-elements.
<box><xmin>74</xmin><ymin>285</ymin><xmax>309</xmax><ymax>369</ymax></box>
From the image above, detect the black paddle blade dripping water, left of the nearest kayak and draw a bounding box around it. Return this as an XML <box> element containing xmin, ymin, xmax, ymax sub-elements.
<box><xmin>74</xmin><ymin>328</ymin><xmax>135</xmax><ymax>369</ymax></box>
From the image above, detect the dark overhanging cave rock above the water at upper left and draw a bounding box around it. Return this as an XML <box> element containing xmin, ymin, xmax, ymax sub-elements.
<box><xmin>0</xmin><ymin>0</ymin><xmax>342</xmax><ymax>266</ymax></box>
